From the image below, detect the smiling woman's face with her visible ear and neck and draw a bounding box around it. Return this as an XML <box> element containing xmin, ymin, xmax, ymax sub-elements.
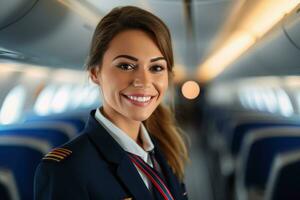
<box><xmin>91</xmin><ymin>30</ymin><xmax>168</xmax><ymax>130</ymax></box>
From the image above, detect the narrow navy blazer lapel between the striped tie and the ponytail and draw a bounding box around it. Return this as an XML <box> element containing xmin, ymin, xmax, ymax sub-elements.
<box><xmin>151</xmin><ymin>138</ymin><xmax>182</xmax><ymax>199</ymax></box>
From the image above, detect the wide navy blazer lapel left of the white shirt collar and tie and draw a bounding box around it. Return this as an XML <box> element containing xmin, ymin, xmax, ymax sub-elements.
<box><xmin>84</xmin><ymin>110</ymin><xmax>152</xmax><ymax>200</ymax></box>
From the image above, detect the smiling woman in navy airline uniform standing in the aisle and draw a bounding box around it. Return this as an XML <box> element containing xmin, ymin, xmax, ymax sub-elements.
<box><xmin>35</xmin><ymin>6</ymin><xmax>188</xmax><ymax>200</ymax></box>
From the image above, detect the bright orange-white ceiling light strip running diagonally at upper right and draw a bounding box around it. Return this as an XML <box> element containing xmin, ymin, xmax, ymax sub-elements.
<box><xmin>197</xmin><ymin>0</ymin><xmax>300</xmax><ymax>82</ymax></box>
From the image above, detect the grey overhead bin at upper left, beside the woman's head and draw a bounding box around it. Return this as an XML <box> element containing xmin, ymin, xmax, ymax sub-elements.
<box><xmin>0</xmin><ymin>0</ymin><xmax>100</xmax><ymax>68</ymax></box>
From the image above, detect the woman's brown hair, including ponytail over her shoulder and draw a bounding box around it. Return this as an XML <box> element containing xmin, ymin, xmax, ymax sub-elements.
<box><xmin>86</xmin><ymin>6</ymin><xmax>188</xmax><ymax>180</ymax></box>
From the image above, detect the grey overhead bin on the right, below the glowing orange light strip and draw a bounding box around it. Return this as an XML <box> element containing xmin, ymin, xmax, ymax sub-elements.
<box><xmin>216</xmin><ymin>5</ymin><xmax>300</xmax><ymax>81</ymax></box>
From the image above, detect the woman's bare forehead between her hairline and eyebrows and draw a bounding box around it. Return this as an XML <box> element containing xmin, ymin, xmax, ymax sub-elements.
<box><xmin>106</xmin><ymin>30</ymin><xmax>162</xmax><ymax>58</ymax></box>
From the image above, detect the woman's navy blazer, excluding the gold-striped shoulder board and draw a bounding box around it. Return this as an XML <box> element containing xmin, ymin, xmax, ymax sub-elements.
<box><xmin>34</xmin><ymin>110</ymin><xmax>187</xmax><ymax>200</ymax></box>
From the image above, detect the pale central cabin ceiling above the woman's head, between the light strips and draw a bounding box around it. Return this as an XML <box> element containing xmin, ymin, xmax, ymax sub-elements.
<box><xmin>86</xmin><ymin>0</ymin><xmax>235</xmax><ymax>73</ymax></box>
